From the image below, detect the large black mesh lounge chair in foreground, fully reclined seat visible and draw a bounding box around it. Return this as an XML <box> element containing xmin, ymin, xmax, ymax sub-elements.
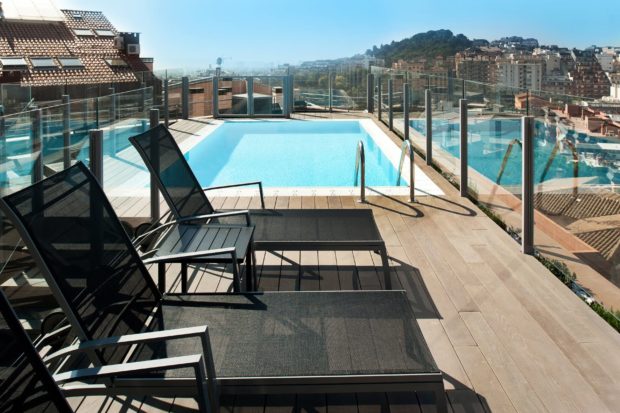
<box><xmin>0</xmin><ymin>164</ymin><xmax>446</xmax><ymax>412</ymax></box>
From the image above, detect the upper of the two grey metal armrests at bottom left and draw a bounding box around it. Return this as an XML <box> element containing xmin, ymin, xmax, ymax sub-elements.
<box><xmin>43</xmin><ymin>326</ymin><xmax>209</xmax><ymax>362</ymax></box>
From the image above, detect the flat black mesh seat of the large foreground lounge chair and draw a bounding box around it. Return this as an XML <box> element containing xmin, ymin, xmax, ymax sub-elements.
<box><xmin>132</xmin><ymin>291</ymin><xmax>439</xmax><ymax>378</ymax></box>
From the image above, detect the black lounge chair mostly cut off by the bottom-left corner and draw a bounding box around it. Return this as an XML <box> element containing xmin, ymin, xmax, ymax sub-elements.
<box><xmin>0</xmin><ymin>284</ymin><xmax>208</xmax><ymax>413</ymax></box>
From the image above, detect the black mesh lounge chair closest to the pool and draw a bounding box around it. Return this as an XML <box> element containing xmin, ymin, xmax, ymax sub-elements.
<box><xmin>129</xmin><ymin>125</ymin><xmax>391</xmax><ymax>289</ymax></box>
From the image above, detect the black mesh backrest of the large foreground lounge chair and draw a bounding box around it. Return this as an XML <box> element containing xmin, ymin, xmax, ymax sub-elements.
<box><xmin>4</xmin><ymin>163</ymin><xmax>161</xmax><ymax>363</ymax></box>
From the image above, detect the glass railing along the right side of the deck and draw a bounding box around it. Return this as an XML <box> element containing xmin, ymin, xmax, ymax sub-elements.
<box><xmin>372</xmin><ymin>68</ymin><xmax>620</xmax><ymax>285</ymax></box>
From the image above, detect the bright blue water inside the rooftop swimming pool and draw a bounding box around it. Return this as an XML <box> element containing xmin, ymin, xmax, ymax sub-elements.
<box><xmin>185</xmin><ymin>121</ymin><xmax>406</xmax><ymax>187</ymax></box>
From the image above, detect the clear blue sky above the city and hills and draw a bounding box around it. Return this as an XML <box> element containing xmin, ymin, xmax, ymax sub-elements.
<box><xmin>55</xmin><ymin>0</ymin><xmax>620</xmax><ymax>69</ymax></box>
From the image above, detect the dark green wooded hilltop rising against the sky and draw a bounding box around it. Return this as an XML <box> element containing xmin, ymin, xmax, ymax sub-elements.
<box><xmin>366</xmin><ymin>30</ymin><xmax>472</xmax><ymax>66</ymax></box>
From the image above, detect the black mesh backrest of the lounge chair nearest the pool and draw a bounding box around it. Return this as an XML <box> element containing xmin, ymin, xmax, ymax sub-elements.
<box><xmin>130</xmin><ymin>125</ymin><xmax>214</xmax><ymax>218</ymax></box>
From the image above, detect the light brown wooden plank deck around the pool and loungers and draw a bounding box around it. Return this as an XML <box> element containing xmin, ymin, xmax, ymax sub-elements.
<box><xmin>60</xmin><ymin>115</ymin><xmax>620</xmax><ymax>413</ymax></box>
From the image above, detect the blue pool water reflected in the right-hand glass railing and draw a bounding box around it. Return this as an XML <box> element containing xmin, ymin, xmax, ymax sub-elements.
<box><xmin>410</xmin><ymin>119</ymin><xmax>619</xmax><ymax>185</ymax></box>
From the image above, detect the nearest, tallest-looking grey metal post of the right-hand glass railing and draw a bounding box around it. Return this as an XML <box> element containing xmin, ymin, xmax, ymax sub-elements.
<box><xmin>521</xmin><ymin>116</ymin><xmax>534</xmax><ymax>254</ymax></box>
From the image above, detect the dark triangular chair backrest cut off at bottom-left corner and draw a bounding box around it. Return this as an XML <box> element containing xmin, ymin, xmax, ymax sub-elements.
<box><xmin>0</xmin><ymin>291</ymin><xmax>71</xmax><ymax>413</ymax></box>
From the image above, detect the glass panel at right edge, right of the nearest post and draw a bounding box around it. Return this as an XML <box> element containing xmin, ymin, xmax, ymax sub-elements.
<box><xmin>528</xmin><ymin>92</ymin><xmax>620</xmax><ymax>286</ymax></box>
